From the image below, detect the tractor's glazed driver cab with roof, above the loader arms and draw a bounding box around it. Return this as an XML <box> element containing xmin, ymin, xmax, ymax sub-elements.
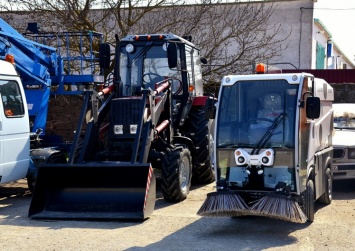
<box><xmin>119</xmin><ymin>34</ymin><xmax>205</xmax><ymax>123</ymax></box>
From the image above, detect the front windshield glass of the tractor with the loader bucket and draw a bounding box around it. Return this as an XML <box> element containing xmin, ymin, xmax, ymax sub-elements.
<box><xmin>120</xmin><ymin>43</ymin><xmax>180</xmax><ymax>96</ymax></box>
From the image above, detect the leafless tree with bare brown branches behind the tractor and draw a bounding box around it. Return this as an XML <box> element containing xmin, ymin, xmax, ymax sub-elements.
<box><xmin>0</xmin><ymin>0</ymin><xmax>288</xmax><ymax>89</ymax></box>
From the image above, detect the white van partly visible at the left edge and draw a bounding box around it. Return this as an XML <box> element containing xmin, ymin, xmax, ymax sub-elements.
<box><xmin>0</xmin><ymin>60</ymin><xmax>30</xmax><ymax>184</ymax></box>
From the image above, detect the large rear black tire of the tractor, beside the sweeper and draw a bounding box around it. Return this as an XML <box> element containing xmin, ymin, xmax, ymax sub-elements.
<box><xmin>185</xmin><ymin>107</ymin><xmax>215</xmax><ymax>184</ymax></box>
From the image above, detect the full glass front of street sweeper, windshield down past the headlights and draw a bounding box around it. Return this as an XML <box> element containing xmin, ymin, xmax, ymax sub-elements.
<box><xmin>216</xmin><ymin>79</ymin><xmax>299</xmax><ymax>191</ymax></box>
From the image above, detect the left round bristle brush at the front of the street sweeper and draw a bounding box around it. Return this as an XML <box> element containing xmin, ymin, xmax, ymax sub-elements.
<box><xmin>197</xmin><ymin>192</ymin><xmax>249</xmax><ymax>217</ymax></box>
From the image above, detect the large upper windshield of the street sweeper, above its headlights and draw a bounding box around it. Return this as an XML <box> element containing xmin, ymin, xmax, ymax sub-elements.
<box><xmin>216</xmin><ymin>80</ymin><xmax>298</xmax><ymax>148</ymax></box>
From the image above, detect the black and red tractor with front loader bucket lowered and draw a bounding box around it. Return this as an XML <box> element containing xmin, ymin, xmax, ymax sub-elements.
<box><xmin>29</xmin><ymin>34</ymin><xmax>215</xmax><ymax>219</ymax></box>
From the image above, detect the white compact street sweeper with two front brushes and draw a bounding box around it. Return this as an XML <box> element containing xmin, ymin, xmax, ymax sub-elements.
<box><xmin>198</xmin><ymin>65</ymin><xmax>334</xmax><ymax>223</ymax></box>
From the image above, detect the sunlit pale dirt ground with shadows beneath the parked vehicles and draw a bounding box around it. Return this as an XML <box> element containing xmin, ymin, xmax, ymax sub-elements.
<box><xmin>0</xmin><ymin>180</ymin><xmax>355</xmax><ymax>251</ymax></box>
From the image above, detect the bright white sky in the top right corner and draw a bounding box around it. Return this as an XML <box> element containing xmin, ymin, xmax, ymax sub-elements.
<box><xmin>314</xmin><ymin>0</ymin><xmax>355</xmax><ymax>63</ymax></box>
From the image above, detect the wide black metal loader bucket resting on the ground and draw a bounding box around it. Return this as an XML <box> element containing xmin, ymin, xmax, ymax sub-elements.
<box><xmin>28</xmin><ymin>162</ymin><xmax>156</xmax><ymax>219</ymax></box>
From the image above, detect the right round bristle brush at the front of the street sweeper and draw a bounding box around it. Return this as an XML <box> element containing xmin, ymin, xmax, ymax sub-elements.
<box><xmin>250</xmin><ymin>196</ymin><xmax>307</xmax><ymax>223</ymax></box>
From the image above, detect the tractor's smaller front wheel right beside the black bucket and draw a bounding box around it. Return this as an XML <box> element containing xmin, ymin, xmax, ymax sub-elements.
<box><xmin>161</xmin><ymin>146</ymin><xmax>191</xmax><ymax>202</ymax></box>
